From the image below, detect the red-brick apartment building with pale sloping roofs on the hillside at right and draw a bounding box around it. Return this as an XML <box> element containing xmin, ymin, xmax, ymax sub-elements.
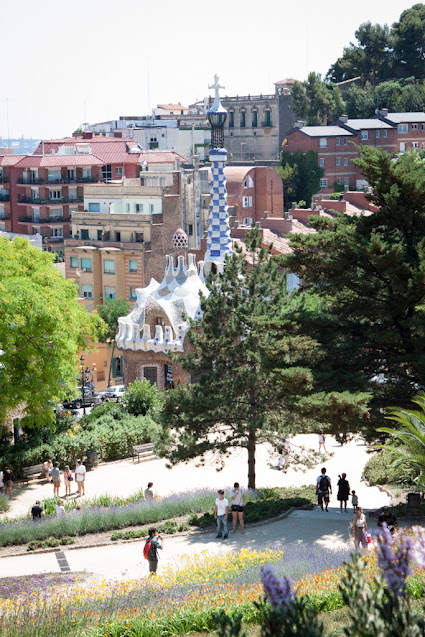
<box><xmin>282</xmin><ymin>109</ymin><xmax>425</xmax><ymax>193</ymax></box>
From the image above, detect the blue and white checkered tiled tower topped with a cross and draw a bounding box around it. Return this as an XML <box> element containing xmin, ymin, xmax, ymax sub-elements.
<box><xmin>203</xmin><ymin>75</ymin><xmax>232</xmax><ymax>276</ymax></box>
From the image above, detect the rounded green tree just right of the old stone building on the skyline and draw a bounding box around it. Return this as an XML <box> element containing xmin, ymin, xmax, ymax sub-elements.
<box><xmin>291</xmin><ymin>72</ymin><xmax>344</xmax><ymax>126</ymax></box>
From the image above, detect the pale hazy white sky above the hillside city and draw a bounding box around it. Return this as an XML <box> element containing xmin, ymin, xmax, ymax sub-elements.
<box><xmin>0</xmin><ymin>0</ymin><xmax>414</xmax><ymax>139</ymax></box>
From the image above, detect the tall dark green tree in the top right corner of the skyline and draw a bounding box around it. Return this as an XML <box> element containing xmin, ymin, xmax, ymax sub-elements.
<box><xmin>391</xmin><ymin>3</ymin><xmax>425</xmax><ymax>78</ymax></box>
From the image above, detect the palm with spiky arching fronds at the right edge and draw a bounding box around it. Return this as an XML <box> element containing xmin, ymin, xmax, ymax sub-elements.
<box><xmin>375</xmin><ymin>392</ymin><xmax>425</xmax><ymax>486</ymax></box>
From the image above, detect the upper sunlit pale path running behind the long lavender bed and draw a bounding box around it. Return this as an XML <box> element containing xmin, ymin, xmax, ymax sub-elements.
<box><xmin>4</xmin><ymin>435</ymin><xmax>388</xmax><ymax>517</ymax></box>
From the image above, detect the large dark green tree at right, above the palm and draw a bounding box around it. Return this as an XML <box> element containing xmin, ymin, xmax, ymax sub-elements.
<box><xmin>282</xmin><ymin>147</ymin><xmax>425</xmax><ymax>417</ymax></box>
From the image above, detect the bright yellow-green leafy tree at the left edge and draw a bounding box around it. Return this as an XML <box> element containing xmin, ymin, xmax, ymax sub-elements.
<box><xmin>0</xmin><ymin>238</ymin><xmax>102</xmax><ymax>426</ymax></box>
